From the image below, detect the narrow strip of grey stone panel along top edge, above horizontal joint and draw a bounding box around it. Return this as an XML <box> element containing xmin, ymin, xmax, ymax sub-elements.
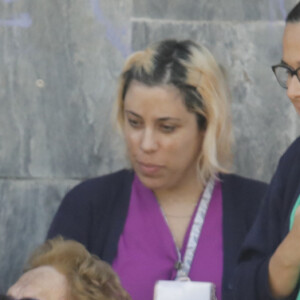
<box><xmin>133</xmin><ymin>0</ymin><xmax>297</xmax><ymax>21</ymax></box>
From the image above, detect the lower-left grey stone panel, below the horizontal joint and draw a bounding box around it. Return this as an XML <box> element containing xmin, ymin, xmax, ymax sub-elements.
<box><xmin>0</xmin><ymin>180</ymin><xmax>77</xmax><ymax>293</ymax></box>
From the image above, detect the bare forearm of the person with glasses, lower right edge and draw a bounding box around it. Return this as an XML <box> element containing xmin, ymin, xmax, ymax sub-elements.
<box><xmin>269</xmin><ymin>206</ymin><xmax>300</xmax><ymax>298</ymax></box>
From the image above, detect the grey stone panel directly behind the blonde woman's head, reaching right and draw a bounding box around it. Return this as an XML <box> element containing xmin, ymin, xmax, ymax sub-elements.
<box><xmin>132</xmin><ymin>20</ymin><xmax>299</xmax><ymax>181</ymax></box>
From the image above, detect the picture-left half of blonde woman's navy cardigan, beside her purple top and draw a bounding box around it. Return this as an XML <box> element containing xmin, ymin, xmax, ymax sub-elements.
<box><xmin>47</xmin><ymin>170</ymin><xmax>134</xmax><ymax>263</ymax></box>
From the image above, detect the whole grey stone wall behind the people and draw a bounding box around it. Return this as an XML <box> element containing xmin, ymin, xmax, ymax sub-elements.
<box><xmin>0</xmin><ymin>0</ymin><xmax>300</xmax><ymax>292</ymax></box>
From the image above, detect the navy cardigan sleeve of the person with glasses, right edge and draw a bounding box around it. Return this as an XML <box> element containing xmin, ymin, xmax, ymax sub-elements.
<box><xmin>235</xmin><ymin>138</ymin><xmax>300</xmax><ymax>300</ymax></box>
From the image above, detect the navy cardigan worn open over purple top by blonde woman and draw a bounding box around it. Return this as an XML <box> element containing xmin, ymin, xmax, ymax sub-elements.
<box><xmin>47</xmin><ymin>170</ymin><xmax>266</xmax><ymax>300</ymax></box>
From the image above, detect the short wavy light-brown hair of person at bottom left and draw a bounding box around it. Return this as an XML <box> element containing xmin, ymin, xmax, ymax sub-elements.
<box><xmin>25</xmin><ymin>237</ymin><xmax>131</xmax><ymax>300</ymax></box>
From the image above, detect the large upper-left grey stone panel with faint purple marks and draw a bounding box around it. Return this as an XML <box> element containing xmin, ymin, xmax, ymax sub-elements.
<box><xmin>0</xmin><ymin>0</ymin><xmax>131</xmax><ymax>178</ymax></box>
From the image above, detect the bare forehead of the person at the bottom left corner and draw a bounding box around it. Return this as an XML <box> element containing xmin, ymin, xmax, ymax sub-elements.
<box><xmin>7</xmin><ymin>266</ymin><xmax>68</xmax><ymax>300</ymax></box>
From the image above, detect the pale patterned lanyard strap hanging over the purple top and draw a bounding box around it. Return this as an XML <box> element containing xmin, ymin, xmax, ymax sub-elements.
<box><xmin>175</xmin><ymin>178</ymin><xmax>215</xmax><ymax>280</ymax></box>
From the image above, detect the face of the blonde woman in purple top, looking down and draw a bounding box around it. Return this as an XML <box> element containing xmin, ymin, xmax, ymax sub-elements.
<box><xmin>124</xmin><ymin>81</ymin><xmax>203</xmax><ymax>191</ymax></box>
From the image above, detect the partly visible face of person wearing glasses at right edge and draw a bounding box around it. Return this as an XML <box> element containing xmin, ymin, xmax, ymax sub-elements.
<box><xmin>282</xmin><ymin>22</ymin><xmax>300</xmax><ymax>115</ymax></box>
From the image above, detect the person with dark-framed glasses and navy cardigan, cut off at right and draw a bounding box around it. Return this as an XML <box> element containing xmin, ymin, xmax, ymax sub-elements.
<box><xmin>235</xmin><ymin>2</ymin><xmax>300</xmax><ymax>300</ymax></box>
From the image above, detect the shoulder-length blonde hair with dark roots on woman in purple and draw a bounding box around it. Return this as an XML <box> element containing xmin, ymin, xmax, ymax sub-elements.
<box><xmin>117</xmin><ymin>40</ymin><xmax>233</xmax><ymax>183</ymax></box>
